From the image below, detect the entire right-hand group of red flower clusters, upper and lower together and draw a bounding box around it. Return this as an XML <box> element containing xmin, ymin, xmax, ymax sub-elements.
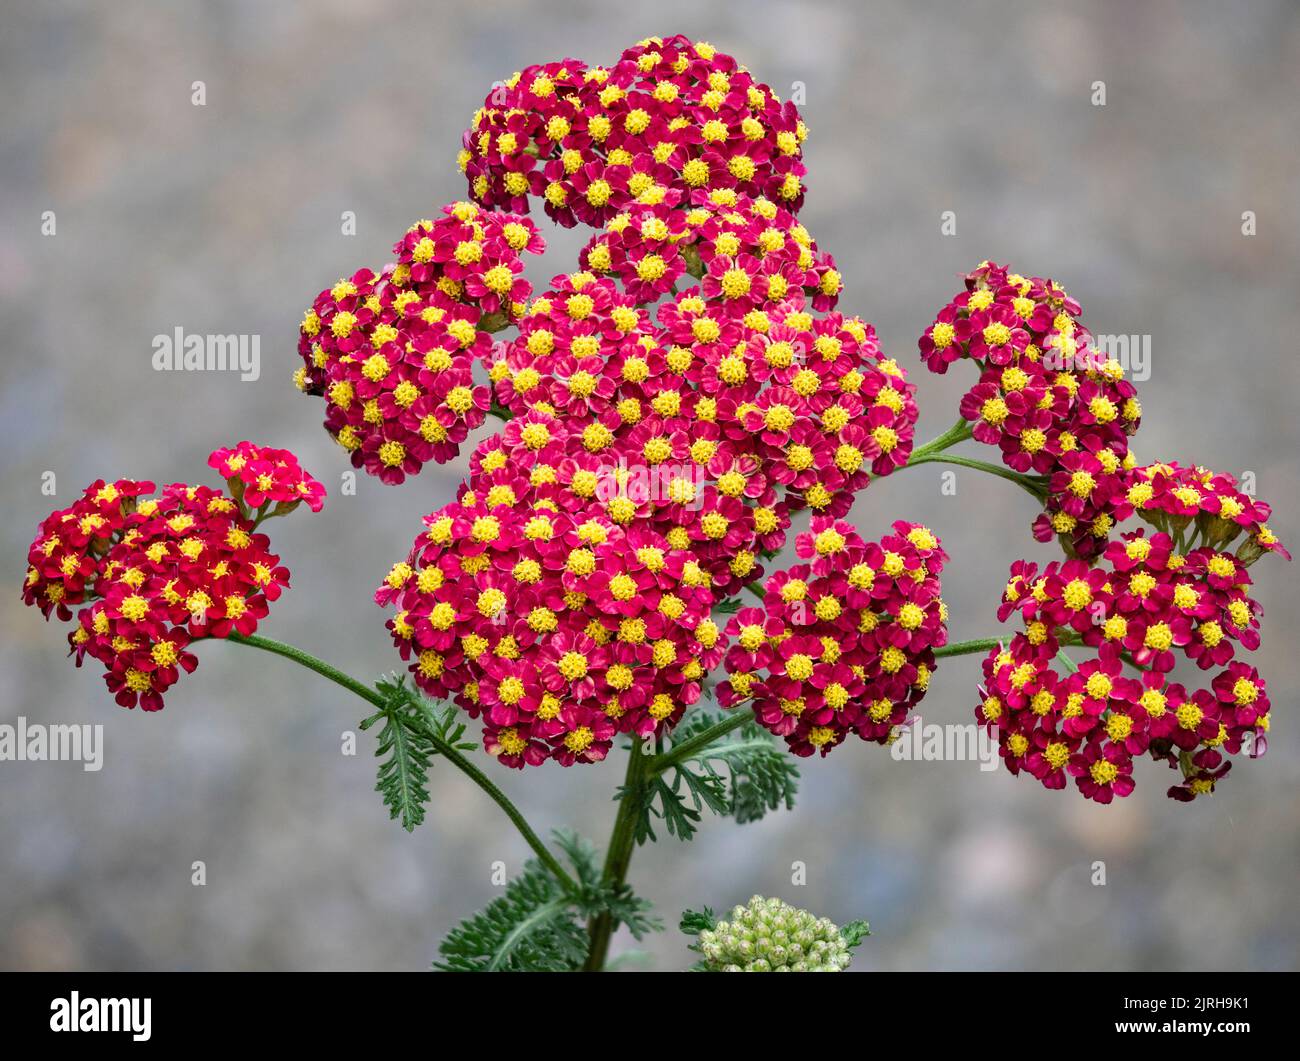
<box><xmin>919</xmin><ymin>261</ymin><xmax>1290</xmax><ymax>802</ymax></box>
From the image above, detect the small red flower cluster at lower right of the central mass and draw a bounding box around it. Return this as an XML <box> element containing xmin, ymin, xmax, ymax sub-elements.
<box><xmin>719</xmin><ymin>517</ymin><xmax>948</xmax><ymax>755</ymax></box>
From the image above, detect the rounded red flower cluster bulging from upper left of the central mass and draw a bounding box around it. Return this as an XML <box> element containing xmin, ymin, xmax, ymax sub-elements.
<box><xmin>295</xmin><ymin>203</ymin><xmax>543</xmax><ymax>482</ymax></box>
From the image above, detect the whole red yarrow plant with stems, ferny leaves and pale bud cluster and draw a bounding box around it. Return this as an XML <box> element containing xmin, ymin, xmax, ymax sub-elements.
<box><xmin>23</xmin><ymin>36</ymin><xmax>1290</xmax><ymax>971</ymax></box>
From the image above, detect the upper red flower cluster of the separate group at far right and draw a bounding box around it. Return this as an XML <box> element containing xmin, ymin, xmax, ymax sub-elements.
<box><xmin>919</xmin><ymin>261</ymin><xmax>1141</xmax><ymax>559</ymax></box>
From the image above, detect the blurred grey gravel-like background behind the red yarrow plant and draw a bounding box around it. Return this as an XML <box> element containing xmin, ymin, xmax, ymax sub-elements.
<box><xmin>0</xmin><ymin>0</ymin><xmax>1300</xmax><ymax>970</ymax></box>
